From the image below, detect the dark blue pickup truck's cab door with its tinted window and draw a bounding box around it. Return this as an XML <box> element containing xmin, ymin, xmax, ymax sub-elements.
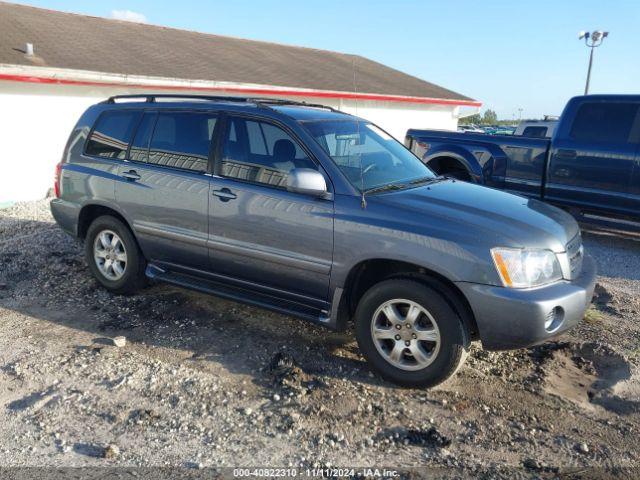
<box><xmin>545</xmin><ymin>101</ymin><xmax>640</xmax><ymax>215</ymax></box>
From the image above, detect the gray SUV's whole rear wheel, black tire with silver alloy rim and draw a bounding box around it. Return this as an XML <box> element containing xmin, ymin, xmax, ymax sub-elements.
<box><xmin>85</xmin><ymin>215</ymin><xmax>147</xmax><ymax>295</ymax></box>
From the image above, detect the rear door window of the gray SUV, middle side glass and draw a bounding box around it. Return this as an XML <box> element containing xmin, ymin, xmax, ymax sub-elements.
<box><xmin>147</xmin><ymin>112</ymin><xmax>216</xmax><ymax>172</ymax></box>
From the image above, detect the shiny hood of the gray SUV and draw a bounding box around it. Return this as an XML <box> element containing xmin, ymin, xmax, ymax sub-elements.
<box><xmin>376</xmin><ymin>180</ymin><xmax>580</xmax><ymax>253</ymax></box>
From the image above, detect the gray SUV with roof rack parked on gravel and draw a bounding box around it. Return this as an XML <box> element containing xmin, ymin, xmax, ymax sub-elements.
<box><xmin>51</xmin><ymin>95</ymin><xmax>595</xmax><ymax>386</ymax></box>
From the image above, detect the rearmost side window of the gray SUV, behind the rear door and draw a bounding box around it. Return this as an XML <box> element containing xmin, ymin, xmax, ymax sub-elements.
<box><xmin>85</xmin><ymin>110</ymin><xmax>142</xmax><ymax>159</ymax></box>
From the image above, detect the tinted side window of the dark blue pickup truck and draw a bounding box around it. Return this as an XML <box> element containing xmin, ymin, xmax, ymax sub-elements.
<box><xmin>571</xmin><ymin>103</ymin><xmax>638</xmax><ymax>144</ymax></box>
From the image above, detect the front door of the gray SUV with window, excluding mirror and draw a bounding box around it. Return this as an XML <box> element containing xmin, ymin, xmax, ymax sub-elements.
<box><xmin>209</xmin><ymin>116</ymin><xmax>333</xmax><ymax>305</ymax></box>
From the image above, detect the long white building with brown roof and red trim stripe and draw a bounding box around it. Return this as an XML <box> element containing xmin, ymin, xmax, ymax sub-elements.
<box><xmin>0</xmin><ymin>2</ymin><xmax>480</xmax><ymax>202</ymax></box>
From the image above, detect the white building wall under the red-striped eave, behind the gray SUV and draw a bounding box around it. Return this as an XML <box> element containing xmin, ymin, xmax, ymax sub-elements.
<box><xmin>0</xmin><ymin>81</ymin><xmax>458</xmax><ymax>203</ymax></box>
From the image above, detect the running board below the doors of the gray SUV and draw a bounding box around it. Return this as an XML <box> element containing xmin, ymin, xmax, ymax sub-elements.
<box><xmin>145</xmin><ymin>264</ymin><xmax>335</xmax><ymax>328</ymax></box>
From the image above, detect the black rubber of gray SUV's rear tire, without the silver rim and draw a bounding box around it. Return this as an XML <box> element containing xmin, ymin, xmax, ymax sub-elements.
<box><xmin>85</xmin><ymin>215</ymin><xmax>144</xmax><ymax>294</ymax></box>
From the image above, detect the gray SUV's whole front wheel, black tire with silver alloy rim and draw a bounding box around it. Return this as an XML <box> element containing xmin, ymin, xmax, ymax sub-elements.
<box><xmin>355</xmin><ymin>279</ymin><xmax>470</xmax><ymax>387</ymax></box>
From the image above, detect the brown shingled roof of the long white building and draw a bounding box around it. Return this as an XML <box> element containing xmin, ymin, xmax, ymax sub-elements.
<box><xmin>0</xmin><ymin>2</ymin><xmax>474</xmax><ymax>104</ymax></box>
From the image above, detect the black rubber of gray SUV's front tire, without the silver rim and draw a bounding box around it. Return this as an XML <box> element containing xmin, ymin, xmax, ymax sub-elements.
<box><xmin>355</xmin><ymin>279</ymin><xmax>469</xmax><ymax>387</ymax></box>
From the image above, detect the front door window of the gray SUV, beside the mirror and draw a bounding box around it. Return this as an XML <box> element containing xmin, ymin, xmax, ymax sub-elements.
<box><xmin>221</xmin><ymin>117</ymin><xmax>317</xmax><ymax>188</ymax></box>
